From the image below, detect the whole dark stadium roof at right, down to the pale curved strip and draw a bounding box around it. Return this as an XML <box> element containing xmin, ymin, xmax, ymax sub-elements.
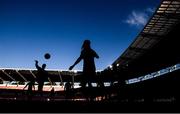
<box><xmin>112</xmin><ymin>0</ymin><xmax>180</xmax><ymax>79</ymax></box>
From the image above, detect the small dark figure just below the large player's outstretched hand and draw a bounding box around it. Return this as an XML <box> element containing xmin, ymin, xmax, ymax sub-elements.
<box><xmin>64</xmin><ymin>81</ymin><xmax>72</xmax><ymax>99</ymax></box>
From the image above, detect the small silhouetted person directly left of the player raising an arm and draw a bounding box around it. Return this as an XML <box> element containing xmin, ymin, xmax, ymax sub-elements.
<box><xmin>23</xmin><ymin>79</ymin><xmax>35</xmax><ymax>99</ymax></box>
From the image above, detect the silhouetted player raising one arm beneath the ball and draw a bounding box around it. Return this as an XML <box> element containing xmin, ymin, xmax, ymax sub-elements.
<box><xmin>35</xmin><ymin>60</ymin><xmax>48</xmax><ymax>95</ymax></box>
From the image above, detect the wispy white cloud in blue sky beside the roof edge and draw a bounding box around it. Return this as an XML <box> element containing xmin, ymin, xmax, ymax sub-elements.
<box><xmin>125</xmin><ymin>8</ymin><xmax>155</xmax><ymax>27</ymax></box>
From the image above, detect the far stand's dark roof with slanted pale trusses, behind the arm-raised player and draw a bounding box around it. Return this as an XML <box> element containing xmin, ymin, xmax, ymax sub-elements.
<box><xmin>0</xmin><ymin>68</ymin><xmax>81</xmax><ymax>84</ymax></box>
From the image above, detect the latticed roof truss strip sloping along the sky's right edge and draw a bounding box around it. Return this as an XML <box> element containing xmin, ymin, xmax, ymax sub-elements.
<box><xmin>112</xmin><ymin>0</ymin><xmax>180</xmax><ymax>67</ymax></box>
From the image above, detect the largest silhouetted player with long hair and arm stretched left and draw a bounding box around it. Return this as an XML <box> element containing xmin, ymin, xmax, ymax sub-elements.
<box><xmin>69</xmin><ymin>40</ymin><xmax>99</xmax><ymax>88</ymax></box>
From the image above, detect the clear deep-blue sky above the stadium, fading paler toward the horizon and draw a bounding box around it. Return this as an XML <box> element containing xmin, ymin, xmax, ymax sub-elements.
<box><xmin>0</xmin><ymin>0</ymin><xmax>160</xmax><ymax>70</ymax></box>
